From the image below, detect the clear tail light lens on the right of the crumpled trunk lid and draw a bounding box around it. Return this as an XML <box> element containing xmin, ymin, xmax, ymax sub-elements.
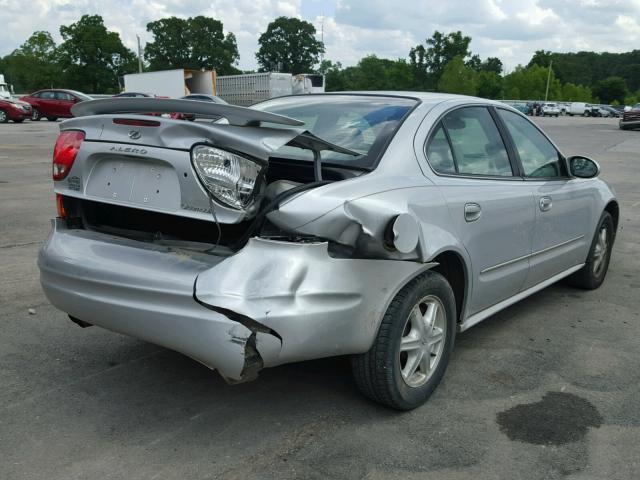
<box><xmin>191</xmin><ymin>145</ymin><xmax>262</xmax><ymax>209</ymax></box>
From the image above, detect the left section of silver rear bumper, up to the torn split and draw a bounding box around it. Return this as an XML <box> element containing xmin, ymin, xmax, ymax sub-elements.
<box><xmin>38</xmin><ymin>220</ymin><xmax>251</xmax><ymax>379</ymax></box>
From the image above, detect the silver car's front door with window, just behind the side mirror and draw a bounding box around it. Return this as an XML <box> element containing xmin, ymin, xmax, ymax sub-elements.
<box><xmin>497</xmin><ymin>109</ymin><xmax>597</xmax><ymax>288</ymax></box>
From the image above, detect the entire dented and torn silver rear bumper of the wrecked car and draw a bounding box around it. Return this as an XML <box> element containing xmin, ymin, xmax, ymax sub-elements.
<box><xmin>38</xmin><ymin>220</ymin><xmax>430</xmax><ymax>381</ymax></box>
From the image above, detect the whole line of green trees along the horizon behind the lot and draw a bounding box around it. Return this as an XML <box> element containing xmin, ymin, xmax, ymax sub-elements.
<box><xmin>0</xmin><ymin>15</ymin><xmax>640</xmax><ymax>104</ymax></box>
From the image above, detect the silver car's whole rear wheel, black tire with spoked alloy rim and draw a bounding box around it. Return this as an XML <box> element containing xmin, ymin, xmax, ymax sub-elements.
<box><xmin>351</xmin><ymin>271</ymin><xmax>456</xmax><ymax>410</ymax></box>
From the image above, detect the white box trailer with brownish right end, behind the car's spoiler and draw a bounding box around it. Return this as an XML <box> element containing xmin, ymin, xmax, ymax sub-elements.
<box><xmin>124</xmin><ymin>68</ymin><xmax>216</xmax><ymax>98</ymax></box>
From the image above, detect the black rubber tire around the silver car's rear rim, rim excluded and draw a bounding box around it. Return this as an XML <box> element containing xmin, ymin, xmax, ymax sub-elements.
<box><xmin>351</xmin><ymin>271</ymin><xmax>456</xmax><ymax>410</ymax></box>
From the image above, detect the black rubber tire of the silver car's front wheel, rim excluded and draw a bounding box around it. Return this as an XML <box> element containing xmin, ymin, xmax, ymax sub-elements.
<box><xmin>567</xmin><ymin>212</ymin><xmax>615</xmax><ymax>290</ymax></box>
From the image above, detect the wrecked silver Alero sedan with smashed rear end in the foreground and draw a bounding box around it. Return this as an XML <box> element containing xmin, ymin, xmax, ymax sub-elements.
<box><xmin>38</xmin><ymin>91</ymin><xmax>619</xmax><ymax>410</ymax></box>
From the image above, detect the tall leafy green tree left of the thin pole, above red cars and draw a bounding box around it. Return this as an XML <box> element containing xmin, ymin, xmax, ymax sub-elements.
<box><xmin>58</xmin><ymin>15</ymin><xmax>137</xmax><ymax>93</ymax></box>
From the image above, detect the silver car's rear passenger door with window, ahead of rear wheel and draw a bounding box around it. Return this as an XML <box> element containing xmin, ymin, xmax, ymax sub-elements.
<box><xmin>426</xmin><ymin>106</ymin><xmax>535</xmax><ymax>315</ymax></box>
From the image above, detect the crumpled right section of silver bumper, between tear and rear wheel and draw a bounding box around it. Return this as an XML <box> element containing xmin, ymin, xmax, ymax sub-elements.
<box><xmin>195</xmin><ymin>238</ymin><xmax>433</xmax><ymax>367</ymax></box>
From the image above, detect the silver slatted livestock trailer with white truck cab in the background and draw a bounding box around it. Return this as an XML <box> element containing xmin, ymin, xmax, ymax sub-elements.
<box><xmin>217</xmin><ymin>72</ymin><xmax>324</xmax><ymax>107</ymax></box>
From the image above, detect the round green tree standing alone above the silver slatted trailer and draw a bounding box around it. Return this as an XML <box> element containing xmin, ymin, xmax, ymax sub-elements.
<box><xmin>256</xmin><ymin>17</ymin><xmax>324</xmax><ymax>74</ymax></box>
